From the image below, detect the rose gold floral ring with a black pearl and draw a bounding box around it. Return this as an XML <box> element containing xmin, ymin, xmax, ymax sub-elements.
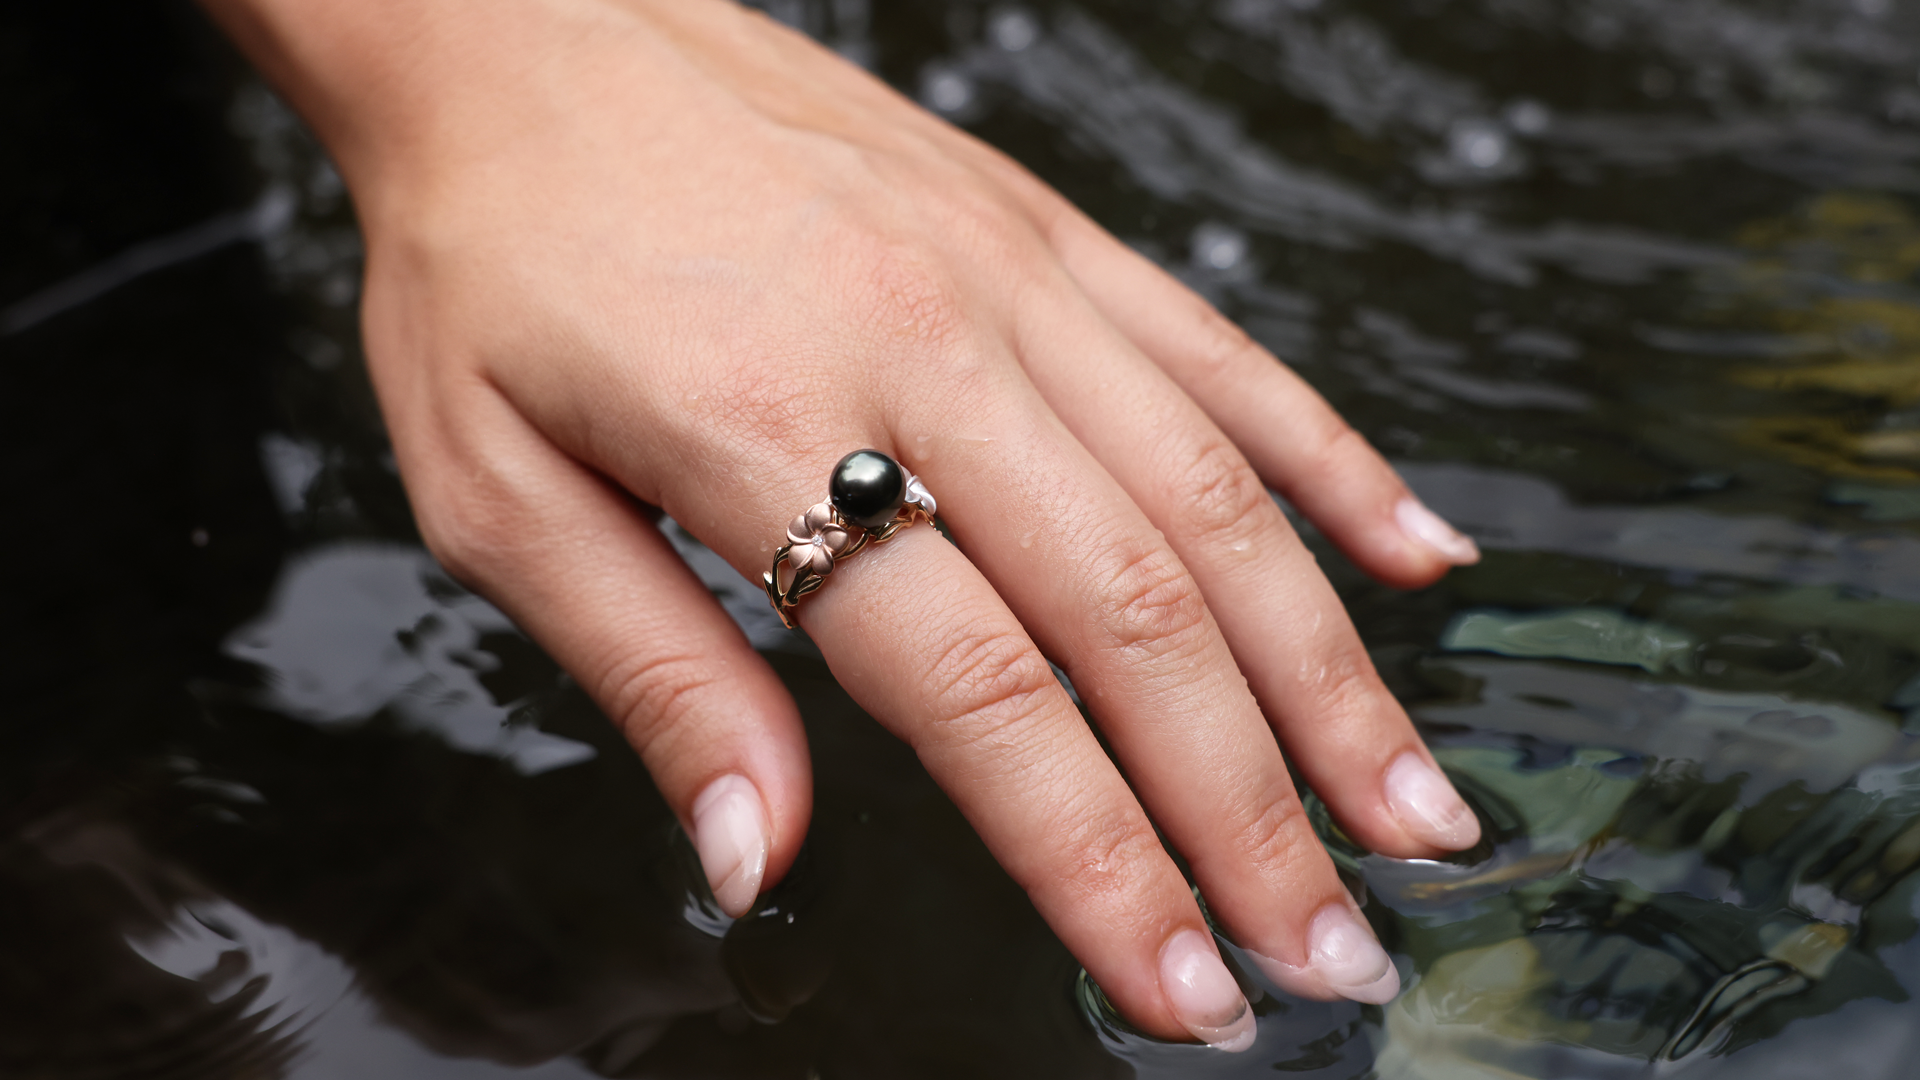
<box><xmin>760</xmin><ymin>450</ymin><xmax>935</xmax><ymax>630</ymax></box>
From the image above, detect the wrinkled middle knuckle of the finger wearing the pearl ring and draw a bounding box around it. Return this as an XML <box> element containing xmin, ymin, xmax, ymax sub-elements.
<box><xmin>927</xmin><ymin>630</ymin><xmax>1060</xmax><ymax>744</ymax></box>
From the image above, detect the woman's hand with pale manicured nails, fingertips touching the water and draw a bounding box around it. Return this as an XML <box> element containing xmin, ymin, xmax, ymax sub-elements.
<box><xmin>198</xmin><ymin>0</ymin><xmax>1478</xmax><ymax>1047</ymax></box>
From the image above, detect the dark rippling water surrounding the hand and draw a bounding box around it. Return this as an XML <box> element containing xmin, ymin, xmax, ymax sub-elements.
<box><xmin>11</xmin><ymin>0</ymin><xmax>1920</xmax><ymax>1080</ymax></box>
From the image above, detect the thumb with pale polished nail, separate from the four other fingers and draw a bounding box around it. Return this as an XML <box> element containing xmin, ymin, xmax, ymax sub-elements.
<box><xmin>396</xmin><ymin>380</ymin><xmax>812</xmax><ymax>917</ymax></box>
